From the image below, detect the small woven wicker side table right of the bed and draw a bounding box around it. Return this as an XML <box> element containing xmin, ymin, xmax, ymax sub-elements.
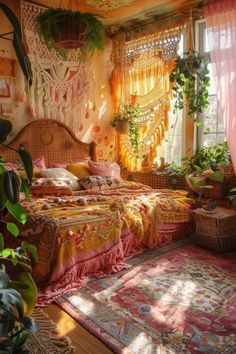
<box><xmin>192</xmin><ymin>207</ymin><xmax>236</xmax><ymax>252</ymax></box>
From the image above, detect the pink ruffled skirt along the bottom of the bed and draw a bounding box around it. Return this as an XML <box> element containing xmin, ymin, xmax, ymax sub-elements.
<box><xmin>38</xmin><ymin>223</ymin><xmax>192</xmax><ymax>306</ymax></box>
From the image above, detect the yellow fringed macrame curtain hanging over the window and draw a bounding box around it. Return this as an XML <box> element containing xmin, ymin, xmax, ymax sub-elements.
<box><xmin>112</xmin><ymin>26</ymin><xmax>183</xmax><ymax>171</ymax></box>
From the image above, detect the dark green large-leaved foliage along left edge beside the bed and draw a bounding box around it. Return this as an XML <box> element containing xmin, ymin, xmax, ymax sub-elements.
<box><xmin>0</xmin><ymin>119</ymin><xmax>38</xmax><ymax>354</ymax></box>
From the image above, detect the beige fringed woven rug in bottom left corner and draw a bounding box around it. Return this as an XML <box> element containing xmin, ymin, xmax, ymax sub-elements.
<box><xmin>25</xmin><ymin>309</ymin><xmax>75</xmax><ymax>354</ymax></box>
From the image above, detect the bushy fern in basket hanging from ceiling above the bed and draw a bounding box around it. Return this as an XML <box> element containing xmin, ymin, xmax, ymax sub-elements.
<box><xmin>36</xmin><ymin>8</ymin><xmax>105</xmax><ymax>56</ymax></box>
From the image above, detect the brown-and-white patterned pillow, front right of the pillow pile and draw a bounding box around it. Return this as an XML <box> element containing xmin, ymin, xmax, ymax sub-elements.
<box><xmin>79</xmin><ymin>176</ymin><xmax>124</xmax><ymax>191</ymax></box>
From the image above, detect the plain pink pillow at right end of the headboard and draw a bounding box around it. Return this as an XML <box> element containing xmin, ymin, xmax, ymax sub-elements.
<box><xmin>88</xmin><ymin>161</ymin><xmax>121</xmax><ymax>180</ymax></box>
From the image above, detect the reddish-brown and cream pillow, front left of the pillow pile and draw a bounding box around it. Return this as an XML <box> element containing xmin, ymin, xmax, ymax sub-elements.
<box><xmin>30</xmin><ymin>178</ymin><xmax>72</xmax><ymax>195</ymax></box>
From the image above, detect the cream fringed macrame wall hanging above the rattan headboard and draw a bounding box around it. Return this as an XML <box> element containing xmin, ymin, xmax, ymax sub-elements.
<box><xmin>22</xmin><ymin>1</ymin><xmax>96</xmax><ymax>134</ymax></box>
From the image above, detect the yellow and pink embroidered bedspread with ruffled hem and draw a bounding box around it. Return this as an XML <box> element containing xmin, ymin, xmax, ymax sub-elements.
<box><xmin>14</xmin><ymin>183</ymin><xmax>191</xmax><ymax>305</ymax></box>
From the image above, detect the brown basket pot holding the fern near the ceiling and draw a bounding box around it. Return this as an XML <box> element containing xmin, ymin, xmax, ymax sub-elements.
<box><xmin>53</xmin><ymin>16</ymin><xmax>86</xmax><ymax>49</ymax></box>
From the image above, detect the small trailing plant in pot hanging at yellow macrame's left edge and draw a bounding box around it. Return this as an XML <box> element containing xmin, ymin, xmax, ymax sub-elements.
<box><xmin>111</xmin><ymin>104</ymin><xmax>141</xmax><ymax>152</ymax></box>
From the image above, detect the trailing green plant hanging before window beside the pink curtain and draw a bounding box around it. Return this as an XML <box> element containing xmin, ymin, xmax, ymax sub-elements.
<box><xmin>170</xmin><ymin>49</ymin><xmax>210</xmax><ymax>122</ymax></box>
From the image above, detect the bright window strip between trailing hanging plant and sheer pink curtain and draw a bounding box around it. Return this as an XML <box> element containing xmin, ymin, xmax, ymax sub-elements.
<box><xmin>196</xmin><ymin>20</ymin><xmax>225</xmax><ymax>146</ymax></box>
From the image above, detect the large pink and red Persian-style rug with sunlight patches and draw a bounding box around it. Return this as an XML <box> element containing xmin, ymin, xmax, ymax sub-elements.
<box><xmin>57</xmin><ymin>245</ymin><xmax>236</xmax><ymax>354</ymax></box>
